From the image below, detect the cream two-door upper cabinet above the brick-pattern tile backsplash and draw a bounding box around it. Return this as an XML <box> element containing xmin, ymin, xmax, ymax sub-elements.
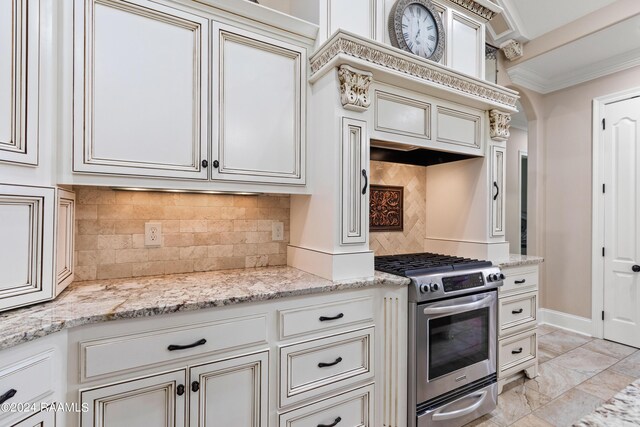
<box><xmin>69</xmin><ymin>0</ymin><xmax>310</xmax><ymax>192</ymax></box>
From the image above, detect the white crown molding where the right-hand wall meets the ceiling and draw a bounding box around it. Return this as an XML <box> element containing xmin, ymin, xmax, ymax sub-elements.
<box><xmin>507</xmin><ymin>49</ymin><xmax>640</xmax><ymax>95</ymax></box>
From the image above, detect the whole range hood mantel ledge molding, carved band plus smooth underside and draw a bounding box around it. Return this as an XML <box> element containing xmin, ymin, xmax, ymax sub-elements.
<box><xmin>309</xmin><ymin>30</ymin><xmax>519</xmax><ymax>112</ymax></box>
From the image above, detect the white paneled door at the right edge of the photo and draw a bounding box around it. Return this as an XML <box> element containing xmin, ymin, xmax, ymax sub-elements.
<box><xmin>604</xmin><ymin>98</ymin><xmax>640</xmax><ymax>347</ymax></box>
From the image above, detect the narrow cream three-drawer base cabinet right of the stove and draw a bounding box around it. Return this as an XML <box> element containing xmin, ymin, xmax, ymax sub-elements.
<box><xmin>498</xmin><ymin>265</ymin><xmax>538</xmax><ymax>392</ymax></box>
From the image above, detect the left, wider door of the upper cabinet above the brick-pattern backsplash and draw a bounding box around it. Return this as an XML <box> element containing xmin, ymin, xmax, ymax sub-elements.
<box><xmin>73</xmin><ymin>0</ymin><xmax>209</xmax><ymax>179</ymax></box>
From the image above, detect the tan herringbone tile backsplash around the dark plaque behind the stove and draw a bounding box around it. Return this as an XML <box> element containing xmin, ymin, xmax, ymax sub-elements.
<box><xmin>369</xmin><ymin>161</ymin><xmax>427</xmax><ymax>255</ymax></box>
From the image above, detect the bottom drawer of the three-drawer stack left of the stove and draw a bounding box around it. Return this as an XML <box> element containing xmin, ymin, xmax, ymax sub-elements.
<box><xmin>278</xmin><ymin>384</ymin><xmax>374</xmax><ymax>427</ymax></box>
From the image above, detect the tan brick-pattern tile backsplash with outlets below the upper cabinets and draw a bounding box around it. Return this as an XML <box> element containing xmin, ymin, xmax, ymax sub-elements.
<box><xmin>74</xmin><ymin>187</ymin><xmax>290</xmax><ymax>281</ymax></box>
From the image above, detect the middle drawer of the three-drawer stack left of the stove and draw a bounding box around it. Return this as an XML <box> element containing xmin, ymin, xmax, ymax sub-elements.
<box><xmin>280</xmin><ymin>328</ymin><xmax>374</xmax><ymax>406</ymax></box>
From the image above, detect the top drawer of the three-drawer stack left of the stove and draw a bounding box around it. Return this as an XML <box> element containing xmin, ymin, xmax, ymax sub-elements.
<box><xmin>280</xmin><ymin>297</ymin><xmax>373</xmax><ymax>339</ymax></box>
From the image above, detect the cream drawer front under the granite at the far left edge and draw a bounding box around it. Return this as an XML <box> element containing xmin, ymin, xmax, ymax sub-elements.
<box><xmin>0</xmin><ymin>351</ymin><xmax>54</xmax><ymax>425</ymax></box>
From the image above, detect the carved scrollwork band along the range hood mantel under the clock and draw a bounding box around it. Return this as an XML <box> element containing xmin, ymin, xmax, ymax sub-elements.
<box><xmin>310</xmin><ymin>31</ymin><xmax>519</xmax><ymax>109</ymax></box>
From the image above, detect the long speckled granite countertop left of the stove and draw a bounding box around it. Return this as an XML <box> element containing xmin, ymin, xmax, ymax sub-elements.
<box><xmin>0</xmin><ymin>266</ymin><xmax>409</xmax><ymax>350</ymax></box>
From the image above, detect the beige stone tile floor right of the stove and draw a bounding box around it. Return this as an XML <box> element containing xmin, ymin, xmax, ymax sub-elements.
<box><xmin>465</xmin><ymin>325</ymin><xmax>640</xmax><ymax>427</ymax></box>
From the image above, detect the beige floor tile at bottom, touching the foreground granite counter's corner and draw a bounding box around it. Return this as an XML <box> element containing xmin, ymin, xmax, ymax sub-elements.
<box><xmin>534</xmin><ymin>389</ymin><xmax>604</xmax><ymax>427</ymax></box>
